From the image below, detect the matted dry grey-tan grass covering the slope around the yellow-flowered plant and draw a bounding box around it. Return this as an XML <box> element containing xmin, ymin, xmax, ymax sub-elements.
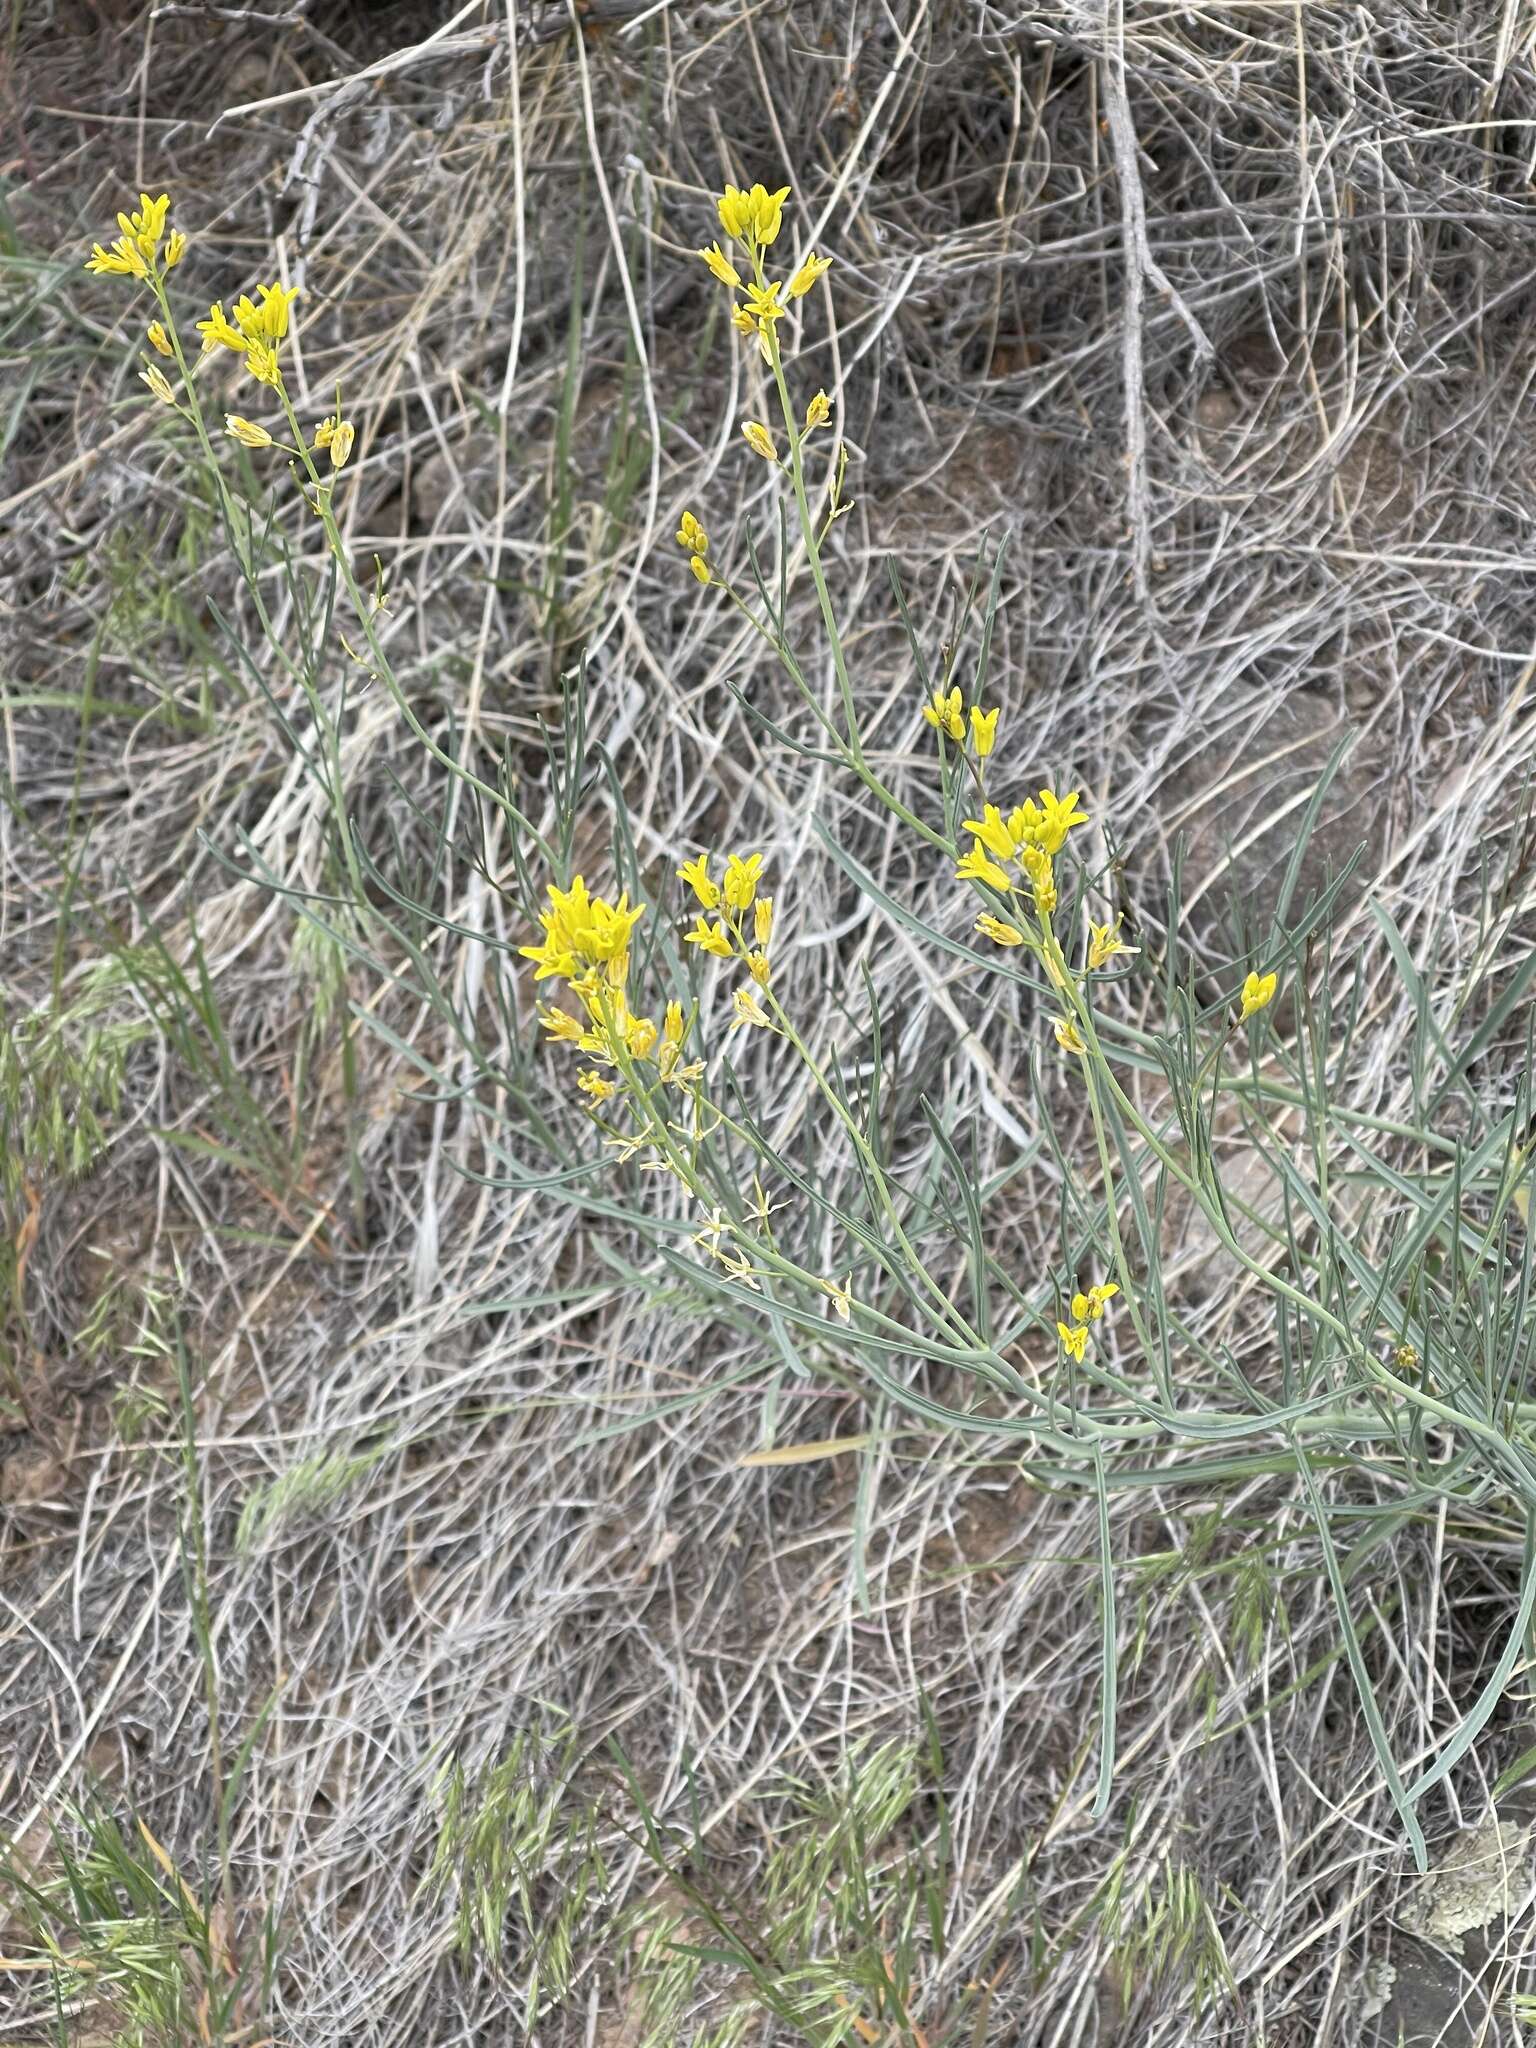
<box><xmin>0</xmin><ymin>0</ymin><xmax>1536</xmax><ymax>2048</ymax></box>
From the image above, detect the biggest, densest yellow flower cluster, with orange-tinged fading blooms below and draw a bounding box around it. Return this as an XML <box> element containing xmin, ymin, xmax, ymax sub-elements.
<box><xmin>518</xmin><ymin>874</ymin><xmax>698</xmax><ymax>1104</ymax></box>
